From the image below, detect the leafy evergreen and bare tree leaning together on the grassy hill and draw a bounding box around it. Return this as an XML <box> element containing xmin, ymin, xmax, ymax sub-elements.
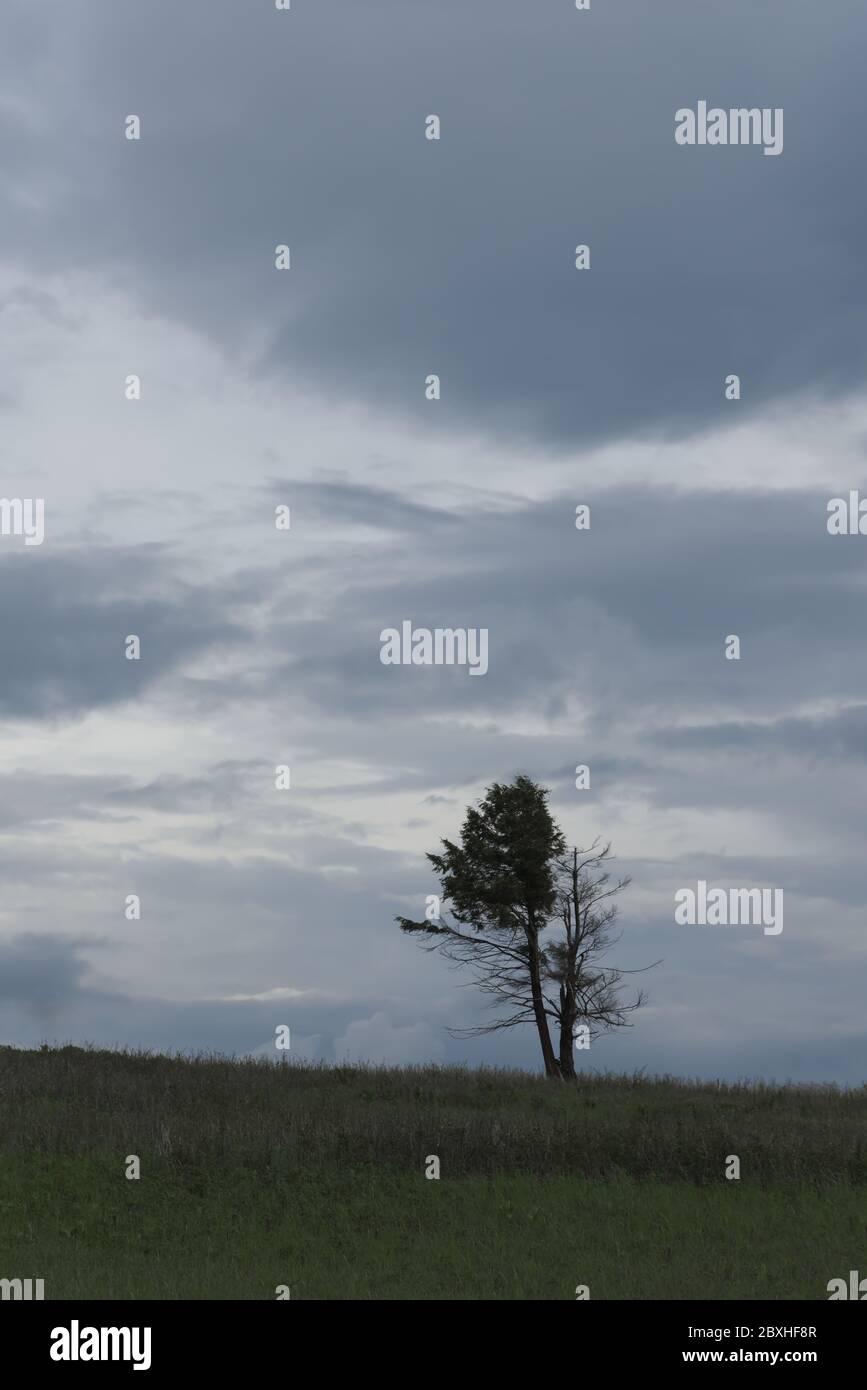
<box><xmin>396</xmin><ymin>774</ymin><xmax>653</xmax><ymax>1079</ymax></box>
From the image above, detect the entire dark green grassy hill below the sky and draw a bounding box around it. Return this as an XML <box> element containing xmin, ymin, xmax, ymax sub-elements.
<box><xmin>0</xmin><ymin>1047</ymin><xmax>867</xmax><ymax>1300</ymax></box>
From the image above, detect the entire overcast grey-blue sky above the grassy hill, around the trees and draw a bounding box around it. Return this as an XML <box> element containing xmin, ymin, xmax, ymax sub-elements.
<box><xmin>0</xmin><ymin>0</ymin><xmax>867</xmax><ymax>1083</ymax></box>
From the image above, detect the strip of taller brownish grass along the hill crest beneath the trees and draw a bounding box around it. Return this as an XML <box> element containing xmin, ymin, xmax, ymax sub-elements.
<box><xmin>6</xmin><ymin>1047</ymin><xmax>867</xmax><ymax>1188</ymax></box>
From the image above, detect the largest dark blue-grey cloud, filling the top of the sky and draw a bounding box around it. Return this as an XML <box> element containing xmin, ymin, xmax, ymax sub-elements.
<box><xmin>3</xmin><ymin>0</ymin><xmax>867</xmax><ymax>445</ymax></box>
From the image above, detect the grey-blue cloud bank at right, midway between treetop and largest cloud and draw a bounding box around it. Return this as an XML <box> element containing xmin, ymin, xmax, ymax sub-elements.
<box><xmin>261</xmin><ymin>485</ymin><xmax>867</xmax><ymax>722</ymax></box>
